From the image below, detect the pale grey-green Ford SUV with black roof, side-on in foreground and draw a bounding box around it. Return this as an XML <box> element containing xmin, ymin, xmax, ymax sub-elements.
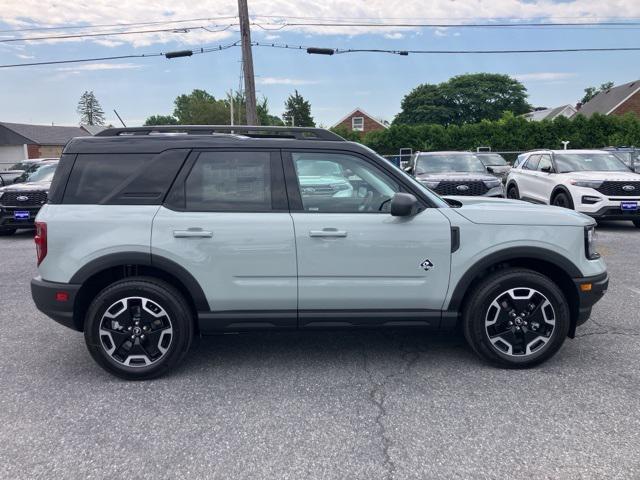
<box><xmin>31</xmin><ymin>126</ymin><xmax>608</xmax><ymax>379</ymax></box>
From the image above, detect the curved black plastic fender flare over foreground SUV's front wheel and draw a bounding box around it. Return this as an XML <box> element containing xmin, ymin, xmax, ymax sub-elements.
<box><xmin>447</xmin><ymin>247</ymin><xmax>583</xmax><ymax>312</ymax></box>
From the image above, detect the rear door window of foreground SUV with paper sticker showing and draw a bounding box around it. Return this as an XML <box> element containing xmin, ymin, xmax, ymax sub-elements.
<box><xmin>185</xmin><ymin>151</ymin><xmax>272</xmax><ymax>212</ymax></box>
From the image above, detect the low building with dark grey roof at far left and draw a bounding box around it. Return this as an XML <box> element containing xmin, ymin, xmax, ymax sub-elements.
<box><xmin>0</xmin><ymin>122</ymin><xmax>91</xmax><ymax>164</ymax></box>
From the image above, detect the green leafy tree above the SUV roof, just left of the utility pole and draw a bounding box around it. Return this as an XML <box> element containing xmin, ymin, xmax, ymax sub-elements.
<box><xmin>173</xmin><ymin>89</ymin><xmax>229</xmax><ymax>125</ymax></box>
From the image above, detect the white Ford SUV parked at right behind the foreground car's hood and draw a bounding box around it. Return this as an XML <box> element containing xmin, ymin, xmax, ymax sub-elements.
<box><xmin>507</xmin><ymin>150</ymin><xmax>640</xmax><ymax>227</ymax></box>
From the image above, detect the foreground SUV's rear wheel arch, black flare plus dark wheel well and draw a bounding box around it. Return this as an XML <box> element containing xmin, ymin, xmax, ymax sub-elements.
<box><xmin>69</xmin><ymin>252</ymin><xmax>209</xmax><ymax>331</ymax></box>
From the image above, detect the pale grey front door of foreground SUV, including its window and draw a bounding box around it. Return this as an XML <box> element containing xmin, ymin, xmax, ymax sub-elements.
<box><xmin>284</xmin><ymin>150</ymin><xmax>451</xmax><ymax>326</ymax></box>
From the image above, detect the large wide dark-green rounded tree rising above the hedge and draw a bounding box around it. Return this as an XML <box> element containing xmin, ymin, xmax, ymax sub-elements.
<box><xmin>394</xmin><ymin>73</ymin><xmax>531</xmax><ymax>125</ymax></box>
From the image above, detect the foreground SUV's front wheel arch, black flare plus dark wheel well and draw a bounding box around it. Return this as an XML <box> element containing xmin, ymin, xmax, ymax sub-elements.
<box><xmin>447</xmin><ymin>247</ymin><xmax>583</xmax><ymax>338</ymax></box>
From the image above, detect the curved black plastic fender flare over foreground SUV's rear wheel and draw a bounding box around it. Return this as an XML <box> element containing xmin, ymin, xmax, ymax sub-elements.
<box><xmin>69</xmin><ymin>252</ymin><xmax>210</xmax><ymax>312</ymax></box>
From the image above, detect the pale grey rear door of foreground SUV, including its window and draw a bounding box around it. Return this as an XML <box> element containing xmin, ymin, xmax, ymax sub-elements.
<box><xmin>151</xmin><ymin>149</ymin><xmax>297</xmax><ymax>328</ymax></box>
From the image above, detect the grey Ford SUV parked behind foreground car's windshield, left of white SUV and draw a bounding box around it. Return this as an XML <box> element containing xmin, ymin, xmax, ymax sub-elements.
<box><xmin>408</xmin><ymin>152</ymin><xmax>504</xmax><ymax>197</ymax></box>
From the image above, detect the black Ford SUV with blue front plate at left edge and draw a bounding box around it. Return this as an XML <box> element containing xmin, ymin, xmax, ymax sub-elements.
<box><xmin>0</xmin><ymin>161</ymin><xmax>58</xmax><ymax>236</ymax></box>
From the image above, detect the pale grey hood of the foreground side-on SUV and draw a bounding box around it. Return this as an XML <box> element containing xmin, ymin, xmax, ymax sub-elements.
<box><xmin>446</xmin><ymin>196</ymin><xmax>594</xmax><ymax>227</ymax></box>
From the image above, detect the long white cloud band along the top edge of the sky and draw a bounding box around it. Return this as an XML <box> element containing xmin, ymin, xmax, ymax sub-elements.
<box><xmin>1</xmin><ymin>0</ymin><xmax>640</xmax><ymax>47</ymax></box>
